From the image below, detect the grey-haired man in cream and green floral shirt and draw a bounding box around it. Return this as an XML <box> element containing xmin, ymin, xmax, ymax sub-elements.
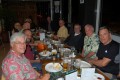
<box><xmin>82</xmin><ymin>24</ymin><xmax>99</xmax><ymax>59</ymax></box>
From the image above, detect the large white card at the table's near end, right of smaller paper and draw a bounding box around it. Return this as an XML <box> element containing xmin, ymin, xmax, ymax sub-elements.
<box><xmin>81</xmin><ymin>68</ymin><xmax>95</xmax><ymax>80</ymax></box>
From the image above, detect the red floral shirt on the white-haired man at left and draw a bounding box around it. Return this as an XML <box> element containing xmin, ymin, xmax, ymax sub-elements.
<box><xmin>2</xmin><ymin>50</ymin><xmax>37</xmax><ymax>80</ymax></box>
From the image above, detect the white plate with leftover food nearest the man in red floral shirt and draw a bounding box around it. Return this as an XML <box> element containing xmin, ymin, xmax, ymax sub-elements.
<box><xmin>45</xmin><ymin>63</ymin><xmax>63</xmax><ymax>72</ymax></box>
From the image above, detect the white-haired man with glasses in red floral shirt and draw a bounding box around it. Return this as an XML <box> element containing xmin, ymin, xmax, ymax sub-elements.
<box><xmin>2</xmin><ymin>33</ymin><xmax>50</xmax><ymax>80</ymax></box>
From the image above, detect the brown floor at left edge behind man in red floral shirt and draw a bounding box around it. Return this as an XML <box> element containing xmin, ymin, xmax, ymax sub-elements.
<box><xmin>0</xmin><ymin>43</ymin><xmax>10</xmax><ymax>79</ymax></box>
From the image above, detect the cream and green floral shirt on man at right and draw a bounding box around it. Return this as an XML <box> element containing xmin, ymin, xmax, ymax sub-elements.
<box><xmin>84</xmin><ymin>33</ymin><xmax>99</xmax><ymax>58</ymax></box>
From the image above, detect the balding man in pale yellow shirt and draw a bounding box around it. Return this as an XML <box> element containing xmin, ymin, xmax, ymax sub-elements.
<box><xmin>54</xmin><ymin>19</ymin><xmax>69</xmax><ymax>39</ymax></box>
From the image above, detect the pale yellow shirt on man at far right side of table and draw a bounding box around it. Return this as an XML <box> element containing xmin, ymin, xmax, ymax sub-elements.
<box><xmin>57</xmin><ymin>26</ymin><xmax>68</xmax><ymax>38</ymax></box>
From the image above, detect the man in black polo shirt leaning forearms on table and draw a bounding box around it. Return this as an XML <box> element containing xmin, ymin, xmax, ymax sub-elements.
<box><xmin>89</xmin><ymin>27</ymin><xmax>119</xmax><ymax>75</ymax></box>
